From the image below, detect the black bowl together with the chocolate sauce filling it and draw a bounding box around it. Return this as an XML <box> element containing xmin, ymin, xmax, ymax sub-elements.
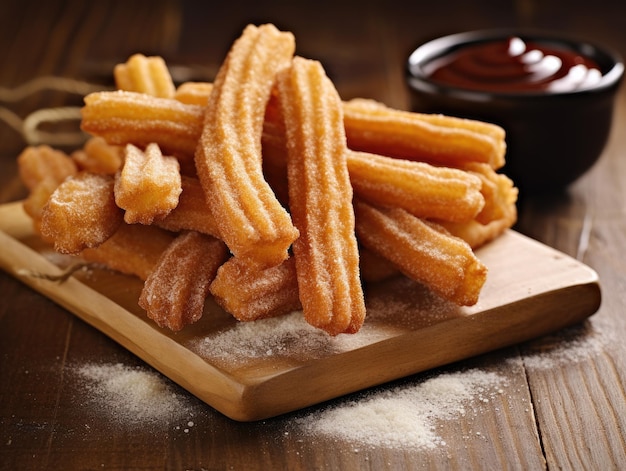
<box><xmin>407</xmin><ymin>30</ymin><xmax>624</xmax><ymax>193</ymax></box>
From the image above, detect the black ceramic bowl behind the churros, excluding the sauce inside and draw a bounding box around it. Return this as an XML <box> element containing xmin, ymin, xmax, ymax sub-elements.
<box><xmin>407</xmin><ymin>30</ymin><xmax>624</xmax><ymax>192</ymax></box>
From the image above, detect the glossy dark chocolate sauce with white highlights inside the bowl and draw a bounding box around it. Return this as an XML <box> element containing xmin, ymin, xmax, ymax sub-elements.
<box><xmin>428</xmin><ymin>37</ymin><xmax>602</xmax><ymax>92</ymax></box>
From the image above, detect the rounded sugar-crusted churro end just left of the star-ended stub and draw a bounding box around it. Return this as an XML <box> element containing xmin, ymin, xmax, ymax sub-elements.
<box><xmin>41</xmin><ymin>172</ymin><xmax>124</xmax><ymax>254</ymax></box>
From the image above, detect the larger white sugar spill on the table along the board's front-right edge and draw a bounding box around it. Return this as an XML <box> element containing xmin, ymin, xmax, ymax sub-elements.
<box><xmin>296</xmin><ymin>370</ymin><xmax>505</xmax><ymax>449</ymax></box>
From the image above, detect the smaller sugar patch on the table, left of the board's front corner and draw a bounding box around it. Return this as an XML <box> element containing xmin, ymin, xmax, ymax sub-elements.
<box><xmin>75</xmin><ymin>363</ymin><xmax>193</xmax><ymax>425</ymax></box>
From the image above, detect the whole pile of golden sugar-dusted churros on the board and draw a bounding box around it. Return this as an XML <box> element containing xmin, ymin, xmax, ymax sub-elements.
<box><xmin>18</xmin><ymin>24</ymin><xmax>517</xmax><ymax>335</ymax></box>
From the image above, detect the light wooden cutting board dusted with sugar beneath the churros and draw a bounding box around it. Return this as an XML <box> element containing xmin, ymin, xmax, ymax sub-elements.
<box><xmin>0</xmin><ymin>202</ymin><xmax>601</xmax><ymax>421</ymax></box>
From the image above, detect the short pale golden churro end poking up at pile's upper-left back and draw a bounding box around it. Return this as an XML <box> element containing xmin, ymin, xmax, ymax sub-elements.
<box><xmin>113</xmin><ymin>54</ymin><xmax>176</xmax><ymax>98</ymax></box>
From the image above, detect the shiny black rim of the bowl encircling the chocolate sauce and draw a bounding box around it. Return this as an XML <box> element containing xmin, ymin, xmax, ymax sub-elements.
<box><xmin>406</xmin><ymin>28</ymin><xmax>624</xmax><ymax>101</ymax></box>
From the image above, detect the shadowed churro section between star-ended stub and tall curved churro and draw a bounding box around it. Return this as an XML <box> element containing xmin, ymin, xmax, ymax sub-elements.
<box><xmin>155</xmin><ymin>175</ymin><xmax>219</xmax><ymax>238</ymax></box>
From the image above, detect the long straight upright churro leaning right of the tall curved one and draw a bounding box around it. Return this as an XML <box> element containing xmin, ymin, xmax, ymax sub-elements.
<box><xmin>278</xmin><ymin>57</ymin><xmax>365</xmax><ymax>335</ymax></box>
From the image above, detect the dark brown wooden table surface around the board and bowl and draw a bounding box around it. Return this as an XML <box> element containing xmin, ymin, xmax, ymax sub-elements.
<box><xmin>0</xmin><ymin>0</ymin><xmax>626</xmax><ymax>470</ymax></box>
